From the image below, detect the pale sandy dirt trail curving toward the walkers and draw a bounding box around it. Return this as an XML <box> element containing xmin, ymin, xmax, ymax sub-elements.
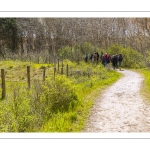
<box><xmin>83</xmin><ymin>70</ymin><xmax>150</xmax><ymax>132</ymax></box>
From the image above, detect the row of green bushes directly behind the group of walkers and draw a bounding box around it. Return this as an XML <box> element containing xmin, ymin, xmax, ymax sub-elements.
<box><xmin>58</xmin><ymin>42</ymin><xmax>146</xmax><ymax>69</ymax></box>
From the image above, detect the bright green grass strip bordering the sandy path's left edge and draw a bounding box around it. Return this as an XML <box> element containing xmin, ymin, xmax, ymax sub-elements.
<box><xmin>41</xmin><ymin>64</ymin><xmax>122</xmax><ymax>132</ymax></box>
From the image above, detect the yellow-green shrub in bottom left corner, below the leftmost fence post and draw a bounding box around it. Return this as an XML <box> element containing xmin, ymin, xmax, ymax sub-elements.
<box><xmin>0</xmin><ymin>84</ymin><xmax>35</xmax><ymax>132</ymax></box>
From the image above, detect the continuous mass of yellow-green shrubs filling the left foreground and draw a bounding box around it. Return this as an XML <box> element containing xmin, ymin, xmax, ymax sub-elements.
<box><xmin>0</xmin><ymin>76</ymin><xmax>78</xmax><ymax>132</ymax></box>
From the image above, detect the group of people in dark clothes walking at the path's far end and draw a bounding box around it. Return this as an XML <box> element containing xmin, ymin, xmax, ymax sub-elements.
<box><xmin>85</xmin><ymin>52</ymin><xmax>123</xmax><ymax>69</ymax></box>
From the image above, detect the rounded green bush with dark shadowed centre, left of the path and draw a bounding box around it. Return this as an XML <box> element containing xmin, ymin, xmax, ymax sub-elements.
<box><xmin>42</xmin><ymin>75</ymin><xmax>78</xmax><ymax>112</ymax></box>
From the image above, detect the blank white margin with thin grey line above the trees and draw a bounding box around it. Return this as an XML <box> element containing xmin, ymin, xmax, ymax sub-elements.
<box><xmin>0</xmin><ymin>0</ymin><xmax>150</xmax><ymax>17</ymax></box>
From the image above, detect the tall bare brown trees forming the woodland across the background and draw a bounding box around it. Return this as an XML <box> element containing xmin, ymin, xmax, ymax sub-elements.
<box><xmin>0</xmin><ymin>18</ymin><xmax>150</xmax><ymax>61</ymax></box>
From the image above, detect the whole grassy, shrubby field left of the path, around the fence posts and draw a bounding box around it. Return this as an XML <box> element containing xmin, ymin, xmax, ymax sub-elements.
<box><xmin>0</xmin><ymin>60</ymin><xmax>122</xmax><ymax>132</ymax></box>
